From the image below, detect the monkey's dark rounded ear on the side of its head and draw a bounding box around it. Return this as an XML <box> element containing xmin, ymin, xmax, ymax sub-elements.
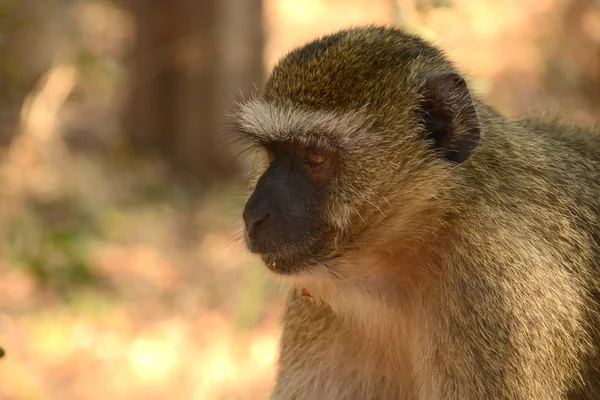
<box><xmin>419</xmin><ymin>72</ymin><xmax>480</xmax><ymax>164</ymax></box>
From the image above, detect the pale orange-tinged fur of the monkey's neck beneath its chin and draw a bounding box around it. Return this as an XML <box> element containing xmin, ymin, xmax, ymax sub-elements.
<box><xmin>291</xmin><ymin>247</ymin><xmax>437</xmax><ymax>332</ymax></box>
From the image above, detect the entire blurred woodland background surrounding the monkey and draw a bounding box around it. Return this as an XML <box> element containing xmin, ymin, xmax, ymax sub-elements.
<box><xmin>0</xmin><ymin>0</ymin><xmax>600</xmax><ymax>400</ymax></box>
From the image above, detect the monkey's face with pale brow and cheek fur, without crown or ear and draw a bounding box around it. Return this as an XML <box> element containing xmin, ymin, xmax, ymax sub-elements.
<box><xmin>237</xmin><ymin>99</ymin><xmax>443</xmax><ymax>278</ymax></box>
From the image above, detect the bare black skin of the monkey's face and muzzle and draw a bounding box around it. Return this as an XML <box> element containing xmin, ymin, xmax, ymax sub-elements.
<box><xmin>243</xmin><ymin>143</ymin><xmax>335</xmax><ymax>274</ymax></box>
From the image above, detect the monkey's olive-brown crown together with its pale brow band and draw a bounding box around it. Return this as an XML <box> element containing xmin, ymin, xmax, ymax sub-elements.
<box><xmin>237</xmin><ymin>27</ymin><xmax>451</xmax><ymax>151</ymax></box>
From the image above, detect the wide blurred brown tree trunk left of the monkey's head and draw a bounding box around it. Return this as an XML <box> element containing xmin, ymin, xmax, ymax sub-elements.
<box><xmin>125</xmin><ymin>0</ymin><xmax>263</xmax><ymax>185</ymax></box>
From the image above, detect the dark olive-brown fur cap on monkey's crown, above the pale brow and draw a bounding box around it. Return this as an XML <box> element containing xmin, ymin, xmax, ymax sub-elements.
<box><xmin>264</xmin><ymin>27</ymin><xmax>451</xmax><ymax>113</ymax></box>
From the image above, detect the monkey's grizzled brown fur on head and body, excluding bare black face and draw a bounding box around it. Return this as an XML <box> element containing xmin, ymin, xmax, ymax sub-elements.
<box><xmin>238</xmin><ymin>27</ymin><xmax>600</xmax><ymax>400</ymax></box>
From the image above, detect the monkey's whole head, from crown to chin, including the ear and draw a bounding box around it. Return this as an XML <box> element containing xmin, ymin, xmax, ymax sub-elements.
<box><xmin>237</xmin><ymin>27</ymin><xmax>479</xmax><ymax>277</ymax></box>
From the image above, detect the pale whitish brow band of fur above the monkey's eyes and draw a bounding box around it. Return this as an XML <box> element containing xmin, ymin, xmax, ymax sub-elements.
<box><xmin>236</xmin><ymin>99</ymin><xmax>372</xmax><ymax>150</ymax></box>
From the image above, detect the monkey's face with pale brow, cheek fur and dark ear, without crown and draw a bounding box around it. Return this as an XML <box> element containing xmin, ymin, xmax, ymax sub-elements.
<box><xmin>237</xmin><ymin>69</ymin><xmax>479</xmax><ymax>278</ymax></box>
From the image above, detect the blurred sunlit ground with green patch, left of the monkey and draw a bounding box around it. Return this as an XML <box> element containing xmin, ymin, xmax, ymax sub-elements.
<box><xmin>0</xmin><ymin>151</ymin><xmax>281</xmax><ymax>399</ymax></box>
